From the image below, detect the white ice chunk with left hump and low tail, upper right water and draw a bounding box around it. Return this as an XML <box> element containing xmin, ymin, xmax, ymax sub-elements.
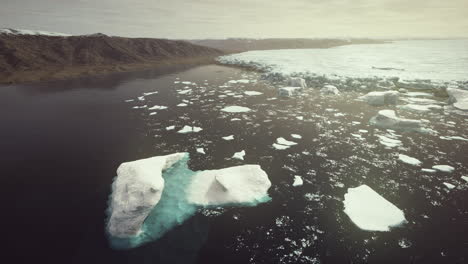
<box><xmin>370</xmin><ymin>110</ymin><xmax>422</xmax><ymax>131</ymax></box>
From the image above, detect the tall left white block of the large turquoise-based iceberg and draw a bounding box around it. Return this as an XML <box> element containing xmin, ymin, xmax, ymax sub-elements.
<box><xmin>107</xmin><ymin>153</ymin><xmax>185</xmax><ymax>238</ymax></box>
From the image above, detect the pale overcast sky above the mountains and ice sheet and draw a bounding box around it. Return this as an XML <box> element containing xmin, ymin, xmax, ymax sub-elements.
<box><xmin>0</xmin><ymin>0</ymin><xmax>468</xmax><ymax>39</ymax></box>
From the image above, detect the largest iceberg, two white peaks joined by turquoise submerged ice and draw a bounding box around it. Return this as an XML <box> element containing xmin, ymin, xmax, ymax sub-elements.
<box><xmin>107</xmin><ymin>153</ymin><xmax>271</xmax><ymax>249</ymax></box>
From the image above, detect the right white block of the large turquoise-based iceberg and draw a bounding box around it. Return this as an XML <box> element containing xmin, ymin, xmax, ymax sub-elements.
<box><xmin>187</xmin><ymin>165</ymin><xmax>271</xmax><ymax>206</ymax></box>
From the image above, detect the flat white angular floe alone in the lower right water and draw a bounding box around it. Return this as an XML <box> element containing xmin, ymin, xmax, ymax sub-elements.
<box><xmin>344</xmin><ymin>185</ymin><xmax>406</xmax><ymax>231</ymax></box>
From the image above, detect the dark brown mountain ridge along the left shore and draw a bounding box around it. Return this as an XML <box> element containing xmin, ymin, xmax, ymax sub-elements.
<box><xmin>0</xmin><ymin>29</ymin><xmax>223</xmax><ymax>83</ymax></box>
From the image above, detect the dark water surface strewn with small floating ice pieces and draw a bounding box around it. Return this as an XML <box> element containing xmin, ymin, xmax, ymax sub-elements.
<box><xmin>0</xmin><ymin>65</ymin><xmax>468</xmax><ymax>263</ymax></box>
